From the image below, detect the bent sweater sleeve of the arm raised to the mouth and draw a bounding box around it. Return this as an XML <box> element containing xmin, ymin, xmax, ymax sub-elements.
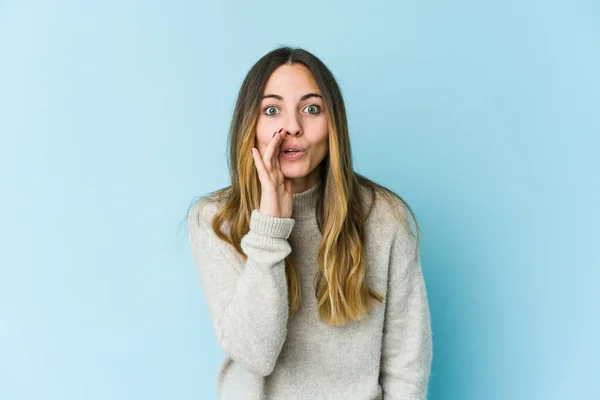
<box><xmin>188</xmin><ymin>202</ymin><xmax>295</xmax><ymax>376</ymax></box>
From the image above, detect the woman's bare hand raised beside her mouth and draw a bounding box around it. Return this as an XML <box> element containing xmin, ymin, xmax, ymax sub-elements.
<box><xmin>251</xmin><ymin>128</ymin><xmax>293</xmax><ymax>218</ymax></box>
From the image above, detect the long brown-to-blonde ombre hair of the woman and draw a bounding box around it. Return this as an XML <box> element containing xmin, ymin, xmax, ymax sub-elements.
<box><xmin>188</xmin><ymin>46</ymin><xmax>420</xmax><ymax>326</ymax></box>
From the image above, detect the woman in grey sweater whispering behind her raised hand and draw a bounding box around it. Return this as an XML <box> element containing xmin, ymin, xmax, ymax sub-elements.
<box><xmin>188</xmin><ymin>47</ymin><xmax>432</xmax><ymax>400</ymax></box>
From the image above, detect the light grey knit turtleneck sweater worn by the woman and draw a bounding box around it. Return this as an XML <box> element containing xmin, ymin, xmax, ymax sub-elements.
<box><xmin>188</xmin><ymin>181</ymin><xmax>433</xmax><ymax>400</ymax></box>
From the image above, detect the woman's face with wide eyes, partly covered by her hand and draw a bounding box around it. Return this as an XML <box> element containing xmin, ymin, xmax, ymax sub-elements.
<box><xmin>256</xmin><ymin>64</ymin><xmax>329</xmax><ymax>193</ymax></box>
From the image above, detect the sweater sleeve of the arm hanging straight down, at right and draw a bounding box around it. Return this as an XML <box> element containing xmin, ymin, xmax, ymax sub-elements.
<box><xmin>379</xmin><ymin>229</ymin><xmax>433</xmax><ymax>400</ymax></box>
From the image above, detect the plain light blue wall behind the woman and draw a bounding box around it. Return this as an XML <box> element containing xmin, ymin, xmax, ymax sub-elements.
<box><xmin>0</xmin><ymin>0</ymin><xmax>600</xmax><ymax>400</ymax></box>
